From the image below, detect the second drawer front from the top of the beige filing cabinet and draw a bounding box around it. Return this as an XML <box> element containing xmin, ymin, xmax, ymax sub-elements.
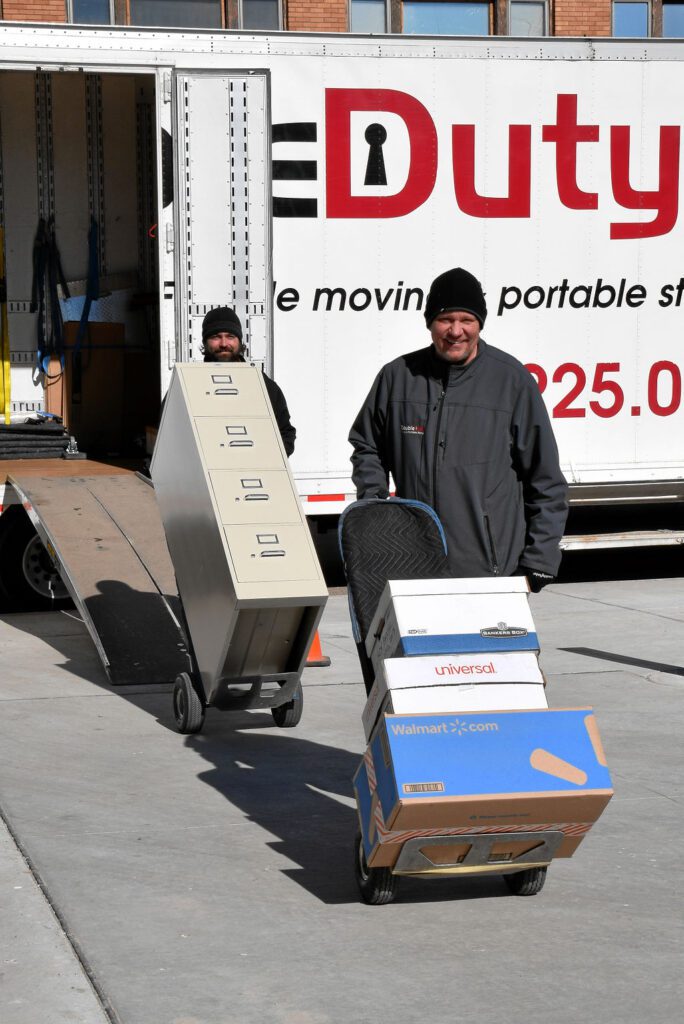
<box><xmin>195</xmin><ymin>416</ymin><xmax>283</xmax><ymax>470</ymax></box>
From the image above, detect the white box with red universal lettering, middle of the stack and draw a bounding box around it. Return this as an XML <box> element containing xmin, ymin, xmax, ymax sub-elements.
<box><xmin>361</xmin><ymin>651</ymin><xmax>547</xmax><ymax>741</ymax></box>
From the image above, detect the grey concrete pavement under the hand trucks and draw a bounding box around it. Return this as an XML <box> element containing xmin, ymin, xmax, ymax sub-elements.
<box><xmin>0</xmin><ymin>580</ymin><xmax>684</xmax><ymax>1024</ymax></box>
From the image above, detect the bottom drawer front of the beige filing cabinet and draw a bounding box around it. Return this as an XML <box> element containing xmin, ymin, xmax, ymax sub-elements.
<box><xmin>223</xmin><ymin>523</ymin><xmax>319</xmax><ymax>583</ymax></box>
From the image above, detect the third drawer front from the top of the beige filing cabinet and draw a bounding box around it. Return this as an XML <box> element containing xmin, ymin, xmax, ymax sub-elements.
<box><xmin>209</xmin><ymin>469</ymin><xmax>301</xmax><ymax>525</ymax></box>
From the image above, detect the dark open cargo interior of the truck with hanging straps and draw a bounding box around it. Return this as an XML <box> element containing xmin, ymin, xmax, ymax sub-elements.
<box><xmin>0</xmin><ymin>70</ymin><xmax>161</xmax><ymax>461</ymax></box>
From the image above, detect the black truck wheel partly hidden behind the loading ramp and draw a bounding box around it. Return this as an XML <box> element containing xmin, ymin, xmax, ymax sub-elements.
<box><xmin>0</xmin><ymin>505</ymin><xmax>73</xmax><ymax>611</ymax></box>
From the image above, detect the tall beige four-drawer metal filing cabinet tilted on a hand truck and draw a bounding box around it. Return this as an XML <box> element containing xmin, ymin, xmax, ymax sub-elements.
<box><xmin>152</xmin><ymin>362</ymin><xmax>328</xmax><ymax>708</ymax></box>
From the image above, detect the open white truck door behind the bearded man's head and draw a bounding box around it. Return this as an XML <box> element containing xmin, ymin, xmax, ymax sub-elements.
<box><xmin>158</xmin><ymin>71</ymin><xmax>272</xmax><ymax>390</ymax></box>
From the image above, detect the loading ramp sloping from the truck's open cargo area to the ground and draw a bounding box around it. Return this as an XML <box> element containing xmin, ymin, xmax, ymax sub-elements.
<box><xmin>5</xmin><ymin>461</ymin><xmax>190</xmax><ymax>686</ymax></box>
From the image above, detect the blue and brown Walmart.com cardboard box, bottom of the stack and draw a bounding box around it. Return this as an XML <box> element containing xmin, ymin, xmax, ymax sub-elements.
<box><xmin>354</xmin><ymin>708</ymin><xmax>612</xmax><ymax>866</ymax></box>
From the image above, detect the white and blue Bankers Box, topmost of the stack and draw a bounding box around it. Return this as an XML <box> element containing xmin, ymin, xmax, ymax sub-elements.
<box><xmin>365</xmin><ymin>577</ymin><xmax>539</xmax><ymax>675</ymax></box>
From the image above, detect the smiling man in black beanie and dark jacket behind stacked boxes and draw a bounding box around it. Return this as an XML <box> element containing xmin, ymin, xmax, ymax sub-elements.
<box><xmin>349</xmin><ymin>267</ymin><xmax>567</xmax><ymax>591</ymax></box>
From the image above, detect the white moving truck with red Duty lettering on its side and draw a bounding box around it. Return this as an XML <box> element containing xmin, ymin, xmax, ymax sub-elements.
<box><xmin>0</xmin><ymin>23</ymin><xmax>684</xmax><ymax>585</ymax></box>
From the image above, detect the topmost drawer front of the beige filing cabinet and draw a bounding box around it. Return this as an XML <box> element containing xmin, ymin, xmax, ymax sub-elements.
<box><xmin>183</xmin><ymin>364</ymin><xmax>269</xmax><ymax>417</ymax></box>
